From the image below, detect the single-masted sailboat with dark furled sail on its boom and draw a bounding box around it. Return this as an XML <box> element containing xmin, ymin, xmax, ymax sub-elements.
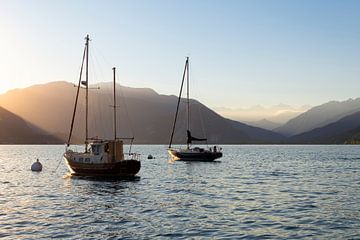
<box><xmin>168</xmin><ymin>57</ymin><xmax>222</xmax><ymax>162</ymax></box>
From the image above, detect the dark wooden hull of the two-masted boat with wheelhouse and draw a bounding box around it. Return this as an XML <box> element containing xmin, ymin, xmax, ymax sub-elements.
<box><xmin>64</xmin><ymin>157</ymin><xmax>141</xmax><ymax>177</ymax></box>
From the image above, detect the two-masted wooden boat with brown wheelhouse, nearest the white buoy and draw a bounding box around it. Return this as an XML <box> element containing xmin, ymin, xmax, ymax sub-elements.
<box><xmin>63</xmin><ymin>35</ymin><xmax>141</xmax><ymax>177</ymax></box>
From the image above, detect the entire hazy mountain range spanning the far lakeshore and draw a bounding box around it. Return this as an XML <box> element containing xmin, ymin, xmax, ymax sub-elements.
<box><xmin>0</xmin><ymin>82</ymin><xmax>360</xmax><ymax>144</ymax></box>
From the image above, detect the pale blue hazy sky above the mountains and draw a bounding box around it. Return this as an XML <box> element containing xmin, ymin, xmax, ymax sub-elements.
<box><xmin>0</xmin><ymin>0</ymin><xmax>360</xmax><ymax>108</ymax></box>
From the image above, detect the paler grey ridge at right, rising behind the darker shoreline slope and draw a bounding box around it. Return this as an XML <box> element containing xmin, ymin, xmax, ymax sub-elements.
<box><xmin>273</xmin><ymin>98</ymin><xmax>360</xmax><ymax>136</ymax></box>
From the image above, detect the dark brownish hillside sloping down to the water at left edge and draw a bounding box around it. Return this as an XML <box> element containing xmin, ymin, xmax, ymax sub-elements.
<box><xmin>0</xmin><ymin>107</ymin><xmax>61</xmax><ymax>144</ymax></box>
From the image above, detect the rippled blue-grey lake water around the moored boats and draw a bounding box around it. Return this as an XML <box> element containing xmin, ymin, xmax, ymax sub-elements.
<box><xmin>0</xmin><ymin>145</ymin><xmax>360</xmax><ymax>239</ymax></box>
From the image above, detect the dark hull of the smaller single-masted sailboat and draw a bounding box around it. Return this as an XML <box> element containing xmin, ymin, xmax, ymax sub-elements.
<box><xmin>168</xmin><ymin>149</ymin><xmax>222</xmax><ymax>162</ymax></box>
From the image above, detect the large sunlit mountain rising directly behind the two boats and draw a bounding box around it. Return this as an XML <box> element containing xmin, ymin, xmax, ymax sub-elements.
<box><xmin>0</xmin><ymin>82</ymin><xmax>283</xmax><ymax>144</ymax></box>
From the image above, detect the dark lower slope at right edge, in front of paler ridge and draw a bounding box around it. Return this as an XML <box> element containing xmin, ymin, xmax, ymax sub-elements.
<box><xmin>287</xmin><ymin>111</ymin><xmax>360</xmax><ymax>144</ymax></box>
